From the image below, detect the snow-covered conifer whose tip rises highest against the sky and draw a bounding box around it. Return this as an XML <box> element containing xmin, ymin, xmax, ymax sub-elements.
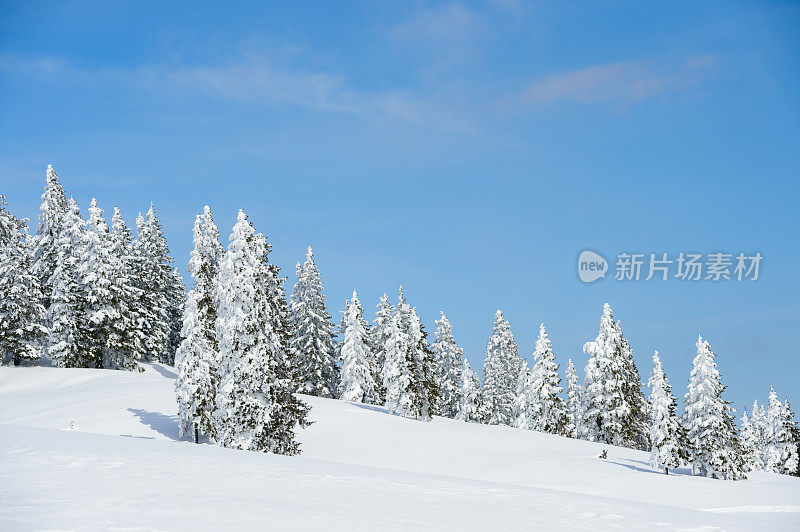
<box><xmin>32</xmin><ymin>164</ymin><xmax>69</xmax><ymax>308</ymax></box>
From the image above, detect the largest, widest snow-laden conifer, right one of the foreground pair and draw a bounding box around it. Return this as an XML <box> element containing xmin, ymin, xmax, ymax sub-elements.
<box><xmin>214</xmin><ymin>210</ymin><xmax>308</xmax><ymax>455</ymax></box>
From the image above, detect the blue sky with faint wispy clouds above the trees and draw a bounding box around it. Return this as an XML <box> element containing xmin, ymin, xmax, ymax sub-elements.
<box><xmin>0</xmin><ymin>0</ymin><xmax>800</xmax><ymax>410</ymax></box>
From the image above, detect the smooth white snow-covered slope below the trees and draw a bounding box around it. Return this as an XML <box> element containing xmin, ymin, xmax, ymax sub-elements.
<box><xmin>0</xmin><ymin>365</ymin><xmax>800</xmax><ymax>530</ymax></box>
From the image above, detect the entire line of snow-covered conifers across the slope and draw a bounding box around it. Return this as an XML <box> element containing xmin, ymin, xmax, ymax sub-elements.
<box><xmin>0</xmin><ymin>167</ymin><xmax>800</xmax><ymax>480</ymax></box>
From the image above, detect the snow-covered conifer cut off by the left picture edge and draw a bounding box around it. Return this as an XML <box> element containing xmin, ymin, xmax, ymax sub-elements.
<box><xmin>0</xmin><ymin>194</ymin><xmax>47</xmax><ymax>366</ymax></box>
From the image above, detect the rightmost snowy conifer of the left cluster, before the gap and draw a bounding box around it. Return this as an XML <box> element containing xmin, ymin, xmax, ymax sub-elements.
<box><xmin>134</xmin><ymin>203</ymin><xmax>182</xmax><ymax>364</ymax></box>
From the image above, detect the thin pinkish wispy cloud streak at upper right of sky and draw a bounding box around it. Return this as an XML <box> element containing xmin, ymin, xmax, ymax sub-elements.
<box><xmin>522</xmin><ymin>55</ymin><xmax>717</xmax><ymax>104</ymax></box>
